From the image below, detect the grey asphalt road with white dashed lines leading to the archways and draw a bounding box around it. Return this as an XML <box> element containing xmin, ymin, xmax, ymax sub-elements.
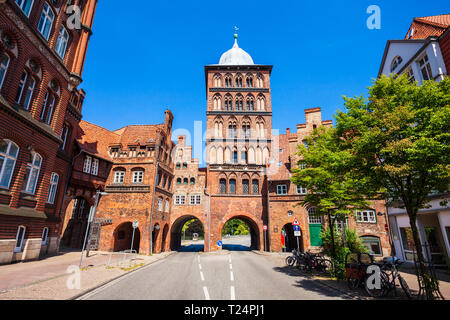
<box><xmin>81</xmin><ymin>248</ymin><xmax>345</xmax><ymax>300</ymax></box>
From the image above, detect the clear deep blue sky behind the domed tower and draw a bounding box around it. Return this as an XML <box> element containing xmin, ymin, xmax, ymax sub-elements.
<box><xmin>81</xmin><ymin>0</ymin><xmax>450</xmax><ymax>152</ymax></box>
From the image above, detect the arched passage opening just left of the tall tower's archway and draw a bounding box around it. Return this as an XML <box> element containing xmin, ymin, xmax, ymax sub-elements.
<box><xmin>170</xmin><ymin>215</ymin><xmax>205</xmax><ymax>251</ymax></box>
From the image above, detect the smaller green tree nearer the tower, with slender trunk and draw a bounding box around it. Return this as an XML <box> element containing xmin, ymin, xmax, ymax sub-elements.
<box><xmin>291</xmin><ymin>127</ymin><xmax>377</xmax><ymax>259</ymax></box>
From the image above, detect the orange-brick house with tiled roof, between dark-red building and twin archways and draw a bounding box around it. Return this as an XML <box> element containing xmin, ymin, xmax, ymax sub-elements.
<box><xmin>81</xmin><ymin>110</ymin><xmax>175</xmax><ymax>254</ymax></box>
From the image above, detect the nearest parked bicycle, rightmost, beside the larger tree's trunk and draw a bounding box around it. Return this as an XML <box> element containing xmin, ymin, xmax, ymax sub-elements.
<box><xmin>364</xmin><ymin>258</ymin><xmax>413</xmax><ymax>299</ymax></box>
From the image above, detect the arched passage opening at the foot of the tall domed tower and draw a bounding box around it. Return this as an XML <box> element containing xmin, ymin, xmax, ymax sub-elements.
<box><xmin>222</xmin><ymin>216</ymin><xmax>260</xmax><ymax>251</ymax></box>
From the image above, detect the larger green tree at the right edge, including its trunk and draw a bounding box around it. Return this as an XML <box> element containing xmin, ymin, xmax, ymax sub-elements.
<box><xmin>336</xmin><ymin>76</ymin><xmax>450</xmax><ymax>299</ymax></box>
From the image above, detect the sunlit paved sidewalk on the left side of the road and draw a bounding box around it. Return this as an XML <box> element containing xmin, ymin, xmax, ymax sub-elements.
<box><xmin>0</xmin><ymin>251</ymin><xmax>172</xmax><ymax>300</ymax></box>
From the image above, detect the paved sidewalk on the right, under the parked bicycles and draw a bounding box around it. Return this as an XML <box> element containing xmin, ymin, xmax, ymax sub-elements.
<box><xmin>253</xmin><ymin>251</ymin><xmax>450</xmax><ymax>300</ymax></box>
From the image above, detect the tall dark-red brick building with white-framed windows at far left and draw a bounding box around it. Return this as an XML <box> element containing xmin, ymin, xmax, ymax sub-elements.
<box><xmin>0</xmin><ymin>0</ymin><xmax>97</xmax><ymax>263</ymax></box>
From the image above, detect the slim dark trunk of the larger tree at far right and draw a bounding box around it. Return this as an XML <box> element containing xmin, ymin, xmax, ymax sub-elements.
<box><xmin>406</xmin><ymin>208</ymin><xmax>434</xmax><ymax>300</ymax></box>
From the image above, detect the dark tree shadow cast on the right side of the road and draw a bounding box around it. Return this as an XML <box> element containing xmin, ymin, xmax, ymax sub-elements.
<box><xmin>273</xmin><ymin>266</ymin><xmax>355</xmax><ymax>299</ymax></box>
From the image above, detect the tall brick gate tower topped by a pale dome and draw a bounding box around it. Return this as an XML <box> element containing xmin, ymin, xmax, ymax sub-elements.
<box><xmin>205</xmin><ymin>34</ymin><xmax>272</xmax><ymax>251</ymax></box>
